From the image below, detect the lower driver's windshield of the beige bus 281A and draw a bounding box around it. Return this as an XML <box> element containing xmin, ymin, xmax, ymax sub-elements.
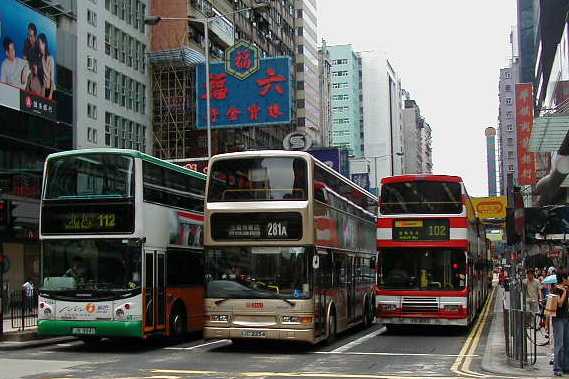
<box><xmin>206</xmin><ymin>247</ymin><xmax>310</xmax><ymax>299</ymax></box>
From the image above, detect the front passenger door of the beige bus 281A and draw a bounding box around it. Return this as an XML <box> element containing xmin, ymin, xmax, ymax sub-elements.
<box><xmin>312</xmin><ymin>250</ymin><xmax>332</xmax><ymax>337</ymax></box>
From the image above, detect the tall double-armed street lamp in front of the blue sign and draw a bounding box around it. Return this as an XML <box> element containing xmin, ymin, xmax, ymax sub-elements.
<box><xmin>144</xmin><ymin>0</ymin><xmax>269</xmax><ymax>159</ymax></box>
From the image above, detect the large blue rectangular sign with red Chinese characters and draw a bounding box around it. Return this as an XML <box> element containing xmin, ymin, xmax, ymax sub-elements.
<box><xmin>196</xmin><ymin>55</ymin><xmax>292</xmax><ymax>129</ymax></box>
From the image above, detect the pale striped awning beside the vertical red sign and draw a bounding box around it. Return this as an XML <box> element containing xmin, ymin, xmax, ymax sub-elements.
<box><xmin>529</xmin><ymin>114</ymin><xmax>569</xmax><ymax>153</ymax></box>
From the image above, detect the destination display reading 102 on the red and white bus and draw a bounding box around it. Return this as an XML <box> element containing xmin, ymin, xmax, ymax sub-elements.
<box><xmin>393</xmin><ymin>219</ymin><xmax>450</xmax><ymax>241</ymax></box>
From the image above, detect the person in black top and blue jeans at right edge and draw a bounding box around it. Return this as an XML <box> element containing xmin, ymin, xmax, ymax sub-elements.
<box><xmin>551</xmin><ymin>273</ymin><xmax>569</xmax><ymax>376</ymax></box>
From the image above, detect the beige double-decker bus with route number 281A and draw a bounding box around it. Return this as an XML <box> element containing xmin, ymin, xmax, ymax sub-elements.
<box><xmin>204</xmin><ymin>151</ymin><xmax>377</xmax><ymax>343</ymax></box>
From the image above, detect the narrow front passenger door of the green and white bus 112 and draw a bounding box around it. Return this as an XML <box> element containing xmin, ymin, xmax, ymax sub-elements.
<box><xmin>143</xmin><ymin>250</ymin><xmax>166</xmax><ymax>333</ymax></box>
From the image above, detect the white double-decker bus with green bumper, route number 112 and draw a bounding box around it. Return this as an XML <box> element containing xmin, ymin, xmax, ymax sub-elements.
<box><xmin>38</xmin><ymin>149</ymin><xmax>206</xmax><ymax>342</ymax></box>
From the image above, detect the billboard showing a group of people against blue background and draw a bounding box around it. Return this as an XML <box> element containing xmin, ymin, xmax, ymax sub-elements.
<box><xmin>0</xmin><ymin>0</ymin><xmax>57</xmax><ymax>120</ymax></box>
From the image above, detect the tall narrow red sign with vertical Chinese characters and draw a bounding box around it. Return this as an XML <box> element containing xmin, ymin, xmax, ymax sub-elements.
<box><xmin>516</xmin><ymin>83</ymin><xmax>536</xmax><ymax>185</ymax></box>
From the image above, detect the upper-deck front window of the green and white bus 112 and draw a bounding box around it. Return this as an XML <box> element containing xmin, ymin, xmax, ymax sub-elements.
<box><xmin>44</xmin><ymin>154</ymin><xmax>134</xmax><ymax>199</ymax></box>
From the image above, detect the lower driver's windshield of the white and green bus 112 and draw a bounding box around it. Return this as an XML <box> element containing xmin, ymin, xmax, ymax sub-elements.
<box><xmin>42</xmin><ymin>239</ymin><xmax>142</xmax><ymax>291</ymax></box>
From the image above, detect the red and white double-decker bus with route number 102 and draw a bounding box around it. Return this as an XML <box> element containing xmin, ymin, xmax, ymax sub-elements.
<box><xmin>376</xmin><ymin>175</ymin><xmax>488</xmax><ymax>326</ymax></box>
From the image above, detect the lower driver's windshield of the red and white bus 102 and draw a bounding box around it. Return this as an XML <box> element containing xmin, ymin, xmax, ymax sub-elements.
<box><xmin>379</xmin><ymin>248</ymin><xmax>466</xmax><ymax>290</ymax></box>
